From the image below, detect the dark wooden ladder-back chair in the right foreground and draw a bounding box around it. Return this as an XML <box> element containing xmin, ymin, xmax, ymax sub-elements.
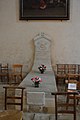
<box><xmin>52</xmin><ymin>92</ymin><xmax>76</xmax><ymax>120</ymax></box>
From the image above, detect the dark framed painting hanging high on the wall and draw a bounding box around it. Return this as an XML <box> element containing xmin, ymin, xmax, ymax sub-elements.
<box><xmin>19</xmin><ymin>0</ymin><xmax>70</xmax><ymax>20</ymax></box>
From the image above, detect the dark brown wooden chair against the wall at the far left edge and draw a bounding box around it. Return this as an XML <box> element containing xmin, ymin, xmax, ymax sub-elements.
<box><xmin>0</xmin><ymin>64</ymin><xmax>9</xmax><ymax>83</ymax></box>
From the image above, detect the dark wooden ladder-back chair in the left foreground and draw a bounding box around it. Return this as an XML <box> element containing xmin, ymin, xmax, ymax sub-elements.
<box><xmin>3</xmin><ymin>86</ymin><xmax>25</xmax><ymax>111</ymax></box>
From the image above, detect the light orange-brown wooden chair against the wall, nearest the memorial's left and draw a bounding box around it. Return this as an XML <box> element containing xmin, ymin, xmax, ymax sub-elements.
<box><xmin>10</xmin><ymin>64</ymin><xmax>23</xmax><ymax>83</ymax></box>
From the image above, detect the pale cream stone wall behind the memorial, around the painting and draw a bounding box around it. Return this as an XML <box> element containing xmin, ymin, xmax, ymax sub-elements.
<box><xmin>0</xmin><ymin>0</ymin><xmax>80</xmax><ymax>74</ymax></box>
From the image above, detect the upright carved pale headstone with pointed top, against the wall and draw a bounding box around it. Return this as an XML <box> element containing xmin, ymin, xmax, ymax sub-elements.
<box><xmin>32</xmin><ymin>33</ymin><xmax>52</xmax><ymax>71</ymax></box>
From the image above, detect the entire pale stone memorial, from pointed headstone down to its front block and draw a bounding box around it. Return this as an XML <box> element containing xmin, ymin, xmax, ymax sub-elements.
<box><xmin>20</xmin><ymin>33</ymin><xmax>57</xmax><ymax>112</ymax></box>
